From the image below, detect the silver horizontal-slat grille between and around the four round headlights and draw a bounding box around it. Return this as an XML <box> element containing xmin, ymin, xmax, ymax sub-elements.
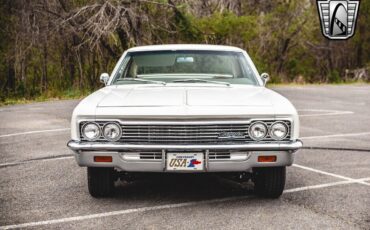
<box><xmin>80</xmin><ymin>121</ymin><xmax>291</xmax><ymax>144</ymax></box>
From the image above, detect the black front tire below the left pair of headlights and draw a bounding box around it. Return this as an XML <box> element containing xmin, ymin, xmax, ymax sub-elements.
<box><xmin>87</xmin><ymin>167</ymin><xmax>115</xmax><ymax>198</ymax></box>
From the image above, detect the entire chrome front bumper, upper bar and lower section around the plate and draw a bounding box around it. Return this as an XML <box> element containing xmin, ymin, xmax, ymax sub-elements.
<box><xmin>67</xmin><ymin>140</ymin><xmax>303</xmax><ymax>172</ymax></box>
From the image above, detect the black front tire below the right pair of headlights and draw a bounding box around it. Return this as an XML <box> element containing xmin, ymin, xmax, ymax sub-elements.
<box><xmin>253</xmin><ymin>167</ymin><xmax>286</xmax><ymax>198</ymax></box>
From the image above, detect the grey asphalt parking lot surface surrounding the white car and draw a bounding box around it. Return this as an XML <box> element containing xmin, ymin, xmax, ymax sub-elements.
<box><xmin>0</xmin><ymin>85</ymin><xmax>370</xmax><ymax>229</ymax></box>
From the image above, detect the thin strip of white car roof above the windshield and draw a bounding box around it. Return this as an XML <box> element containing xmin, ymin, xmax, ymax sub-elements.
<box><xmin>127</xmin><ymin>44</ymin><xmax>243</xmax><ymax>52</ymax></box>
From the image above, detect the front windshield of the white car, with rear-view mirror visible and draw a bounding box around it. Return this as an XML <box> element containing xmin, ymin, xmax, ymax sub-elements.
<box><xmin>112</xmin><ymin>50</ymin><xmax>258</xmax><ymax>85</ymax></box>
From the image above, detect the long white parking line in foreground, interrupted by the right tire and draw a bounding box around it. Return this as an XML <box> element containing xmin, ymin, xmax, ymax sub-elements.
<box><xmin>0</xmin><ymin>178</ymin><xmax>370</xmax><ymax>229</ymax></box>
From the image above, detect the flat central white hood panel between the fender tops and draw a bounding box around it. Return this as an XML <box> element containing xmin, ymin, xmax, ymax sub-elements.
<box><xmin>97</xmin><ymin>86</ymin><xmax>272</xmax><ymax>107</ymax></box>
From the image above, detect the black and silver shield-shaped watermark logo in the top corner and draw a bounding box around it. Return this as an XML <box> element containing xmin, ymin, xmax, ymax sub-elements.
<box><xmin>317</xmin><ymin>0</ymin><xmax>360</xmax><ymax>40</ymax></box>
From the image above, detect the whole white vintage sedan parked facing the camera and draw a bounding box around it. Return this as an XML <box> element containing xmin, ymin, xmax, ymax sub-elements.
<box><xmin>68</xmin><ymin>45</ymin><xmax>302</xmax><ymax>198</ymax></box>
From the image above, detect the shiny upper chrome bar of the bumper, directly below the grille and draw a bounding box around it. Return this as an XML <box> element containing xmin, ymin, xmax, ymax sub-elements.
<box><xmin>67</xmin><ymin>140</ymin><xmax>303</xmax><ymax>151</ymax></box>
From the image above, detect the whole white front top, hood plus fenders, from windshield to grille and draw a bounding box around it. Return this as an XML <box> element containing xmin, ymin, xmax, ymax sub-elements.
<box><xmin>74</xmin><ymin>84</ymin><xmax>297</xmax><ymax>119</ymax></box>
